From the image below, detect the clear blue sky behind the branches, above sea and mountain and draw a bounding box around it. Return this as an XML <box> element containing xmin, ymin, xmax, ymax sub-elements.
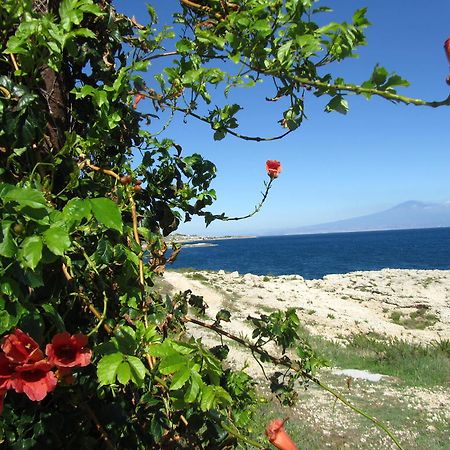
<box><xmin>115</xmin><ymin>0</ymin><xmax>450</xmax><ymax>235</ymax></box>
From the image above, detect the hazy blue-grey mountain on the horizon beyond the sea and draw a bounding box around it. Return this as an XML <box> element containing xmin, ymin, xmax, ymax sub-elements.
<box><xmin>282</xmin><ymin>201</ymin><xmax>450</xmax><ymax>234</ymax></box>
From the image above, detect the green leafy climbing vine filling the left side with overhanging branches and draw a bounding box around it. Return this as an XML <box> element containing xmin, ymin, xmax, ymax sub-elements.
<box><xmin>0</xmin><ymin>0</ymin><xmax>448</xmax><ymax>449</ymax></box>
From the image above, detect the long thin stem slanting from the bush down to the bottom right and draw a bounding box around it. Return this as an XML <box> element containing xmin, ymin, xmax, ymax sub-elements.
<box><xmin>184</xmin><ymin>316</ymin><xmax>404</xmax><ymax>450</ymax></box>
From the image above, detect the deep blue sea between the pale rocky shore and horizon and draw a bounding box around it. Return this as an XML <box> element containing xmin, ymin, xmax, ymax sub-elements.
<box><xmin>168</xmin><ymin>228</ymin><xmax>450</xmax><ymax>279</ymax></box>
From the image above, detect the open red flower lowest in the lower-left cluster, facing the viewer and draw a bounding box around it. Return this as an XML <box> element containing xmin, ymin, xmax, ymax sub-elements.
<box><xmin>12</xmin><ymin>360</ymin><xmax>58</xmax><ymax>401</ymax></box>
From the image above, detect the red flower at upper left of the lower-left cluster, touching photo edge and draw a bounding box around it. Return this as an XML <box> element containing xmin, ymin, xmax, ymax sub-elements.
<box><xmin>1</xmin><ymin>328</ymin><xmax>44</xmax><ymax>364</ymax></box>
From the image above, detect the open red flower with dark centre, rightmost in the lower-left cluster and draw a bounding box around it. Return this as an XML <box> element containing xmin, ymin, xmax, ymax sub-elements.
<box><xmin>45</xmin><ymin>331</ymin><xmax>92</xmax><ymax>368</ymax></box>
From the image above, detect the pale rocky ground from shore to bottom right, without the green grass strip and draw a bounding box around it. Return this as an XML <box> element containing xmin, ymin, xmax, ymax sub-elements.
<box><xmin>160</xmin><ymin>269</ymin><xmax>450</xmax><ymax>449</ymax></box>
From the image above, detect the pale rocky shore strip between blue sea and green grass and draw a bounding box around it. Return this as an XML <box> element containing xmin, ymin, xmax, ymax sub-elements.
<box><xmin>164</xmin><ymin>269</ymin><xmax>450</xmax><ymax>344</ymax></box>
